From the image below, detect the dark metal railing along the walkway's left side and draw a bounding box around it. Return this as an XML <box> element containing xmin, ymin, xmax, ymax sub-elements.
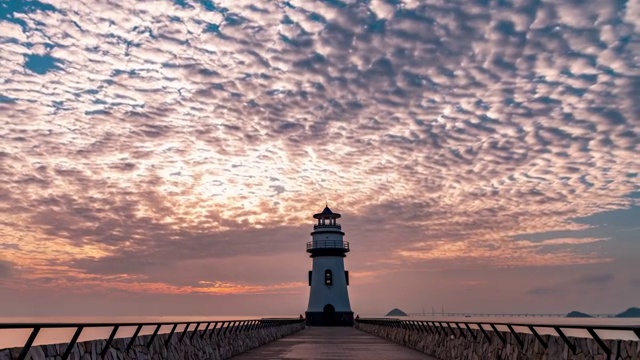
<box><xmin>0</xmin><ymin>319</ymin><xmax>304</xmax><ymax>360</ymax></box>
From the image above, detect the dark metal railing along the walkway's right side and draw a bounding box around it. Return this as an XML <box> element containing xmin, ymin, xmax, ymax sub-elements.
<box><xmin>355</xmin><ymin>318</ymin><xmax>640</xmax><ymax>356</ymax></box>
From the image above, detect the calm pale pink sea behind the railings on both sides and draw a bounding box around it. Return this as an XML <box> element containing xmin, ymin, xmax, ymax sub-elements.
<box><xmin>0</xmin><ymin>314</ymin><xmax>640</xmax><ymax>349</ymax></box>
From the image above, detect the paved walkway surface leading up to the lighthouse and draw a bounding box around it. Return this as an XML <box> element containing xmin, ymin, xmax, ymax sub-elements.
<box><xmin>233</xmin><ymin>327</ymin><xmax>437</xmax><ymax>360</ymax></box>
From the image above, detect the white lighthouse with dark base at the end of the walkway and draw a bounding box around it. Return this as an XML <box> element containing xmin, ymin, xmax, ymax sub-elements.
<box><xmin>306</xmin><ymin>206</ymin><xmax>353</xmax><ymax>326</ymax></box>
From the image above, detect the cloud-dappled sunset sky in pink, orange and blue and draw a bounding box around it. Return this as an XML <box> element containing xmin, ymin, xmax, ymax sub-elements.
<box><xmin>0</xmin><ymin>0</ymin><xmax>640</xmax><ymax>316</ymax></box>
